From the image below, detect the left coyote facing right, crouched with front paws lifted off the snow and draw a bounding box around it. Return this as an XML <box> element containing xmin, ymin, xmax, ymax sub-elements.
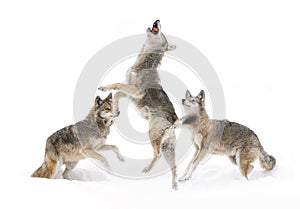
<box><xmin>31</xmin><ymin>94</ymin><xmax>124</xmax><ymax>179</ymax></box>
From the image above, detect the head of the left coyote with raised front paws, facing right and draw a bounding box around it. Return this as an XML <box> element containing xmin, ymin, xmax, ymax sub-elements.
<box><xmin>94</xmin><ymin>93</ymin><xmax>117</xmax><ymax>119</ymax></box>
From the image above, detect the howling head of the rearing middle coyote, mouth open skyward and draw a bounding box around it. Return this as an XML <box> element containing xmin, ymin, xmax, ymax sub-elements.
<box><xmin>143</xmin><ymin>20</ymin><xmax>176</xmax><ymax>52</ymax></box>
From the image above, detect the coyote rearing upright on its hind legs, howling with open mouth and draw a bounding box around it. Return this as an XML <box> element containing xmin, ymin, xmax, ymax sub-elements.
<box><xmin>99</xmin><ymin>20</ymin><xmax>177</xmax><ymax>190</ymax></box>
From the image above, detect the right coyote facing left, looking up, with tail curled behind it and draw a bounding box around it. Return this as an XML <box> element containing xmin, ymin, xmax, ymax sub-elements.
<box><xmin>171</xmin><ymin>90</ymin><xmax>276</xmax><ymax>181</ymax></box>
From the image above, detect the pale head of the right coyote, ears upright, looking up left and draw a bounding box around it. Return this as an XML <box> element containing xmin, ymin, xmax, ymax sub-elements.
<box><xmin>182</xmin><ymin>90</ymin><xmax>205</xmax><ymax>110</ymax></box>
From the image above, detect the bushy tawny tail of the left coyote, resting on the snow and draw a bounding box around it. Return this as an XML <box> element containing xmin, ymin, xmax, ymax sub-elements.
<box><xmin>31</xmin><ymin>143</ymin><xmax>58</xmax><ymax>179</ymax></box>
